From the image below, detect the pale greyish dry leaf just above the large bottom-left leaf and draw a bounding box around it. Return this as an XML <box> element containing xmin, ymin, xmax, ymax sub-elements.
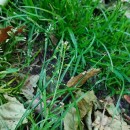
<box><xmin>21</xmin><ymin>75</ymin><xmax>39</xmax><ymax>100</ymax></box>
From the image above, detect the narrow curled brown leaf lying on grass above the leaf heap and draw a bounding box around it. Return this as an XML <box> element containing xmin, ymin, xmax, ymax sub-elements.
<box><xmin>67</xmin><ymin>68</ymin><xmax>100</xmax><ymax>87</ymax></box>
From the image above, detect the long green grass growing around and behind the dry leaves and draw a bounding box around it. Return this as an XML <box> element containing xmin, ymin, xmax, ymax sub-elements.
<box><xmin>0</xmin><ymin>0</ymin><xmax>130</xmax><ymax>130</ymax></box>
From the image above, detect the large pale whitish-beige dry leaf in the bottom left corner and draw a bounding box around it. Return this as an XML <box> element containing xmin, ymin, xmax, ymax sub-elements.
<box><xmin>0</xmin><ymin>95</ymin><xmax>27</xmax><ymax>130</ymax></box>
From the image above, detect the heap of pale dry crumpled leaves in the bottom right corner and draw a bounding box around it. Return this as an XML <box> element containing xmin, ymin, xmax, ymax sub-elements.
<box><xmin>64</xmin><ymin>91</ymin><xmax>130</xmax><ymax>130</ymax></box>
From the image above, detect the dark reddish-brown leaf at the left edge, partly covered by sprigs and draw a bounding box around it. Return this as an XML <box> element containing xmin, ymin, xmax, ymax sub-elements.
<box><xmin>0</xmin><ymin>26</ymin><xmax>25</xmax><ymax>43</ymax></box>
